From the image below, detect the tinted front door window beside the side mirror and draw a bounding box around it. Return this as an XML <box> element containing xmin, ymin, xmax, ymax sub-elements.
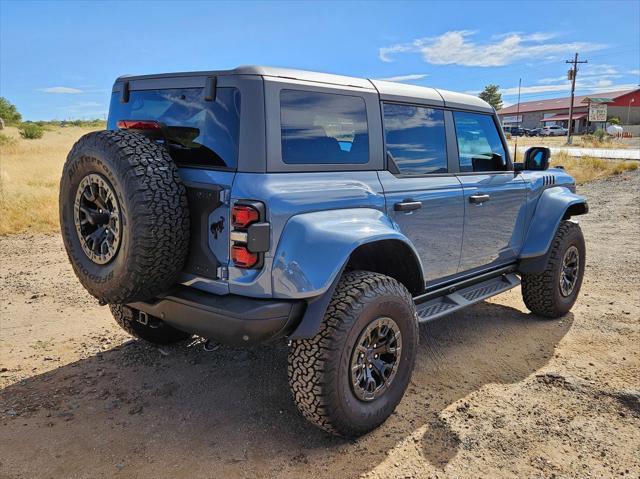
<box><xmin>453</xmin><ymin>111</ymin><xmax>507</xmax><ymax>171</ymax></box>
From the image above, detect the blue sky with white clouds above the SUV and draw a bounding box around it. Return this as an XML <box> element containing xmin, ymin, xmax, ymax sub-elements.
<box><xmin>0</xmin><ymin>0</ymin><xmax>640</xmax><ymax>120</ymax></box>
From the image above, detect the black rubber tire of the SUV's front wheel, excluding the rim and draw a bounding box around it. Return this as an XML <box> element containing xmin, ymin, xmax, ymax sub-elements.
<box><xmin>522</xmin><ymin>221</ymin><xmax>586</xmax><ymax>318</ymax></box>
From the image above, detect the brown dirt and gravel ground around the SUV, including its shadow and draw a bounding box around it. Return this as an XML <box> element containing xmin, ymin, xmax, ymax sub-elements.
<box><xmin>0</xmin><ymin>171</ymin><xmax>640</xmax><ymax>479</ymax></box>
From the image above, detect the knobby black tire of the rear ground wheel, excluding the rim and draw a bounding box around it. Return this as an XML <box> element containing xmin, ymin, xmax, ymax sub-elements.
<box><xmin>288</xmin><ymin>271</ymin><xmax>418</xmax><ymax>437</ymax></box>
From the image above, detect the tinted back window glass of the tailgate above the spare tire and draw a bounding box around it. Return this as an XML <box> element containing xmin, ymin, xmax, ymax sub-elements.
<box><xmin>108</xmin><ymin>88</ymin><xmax>240</xmax><ymax>169</ymax></box>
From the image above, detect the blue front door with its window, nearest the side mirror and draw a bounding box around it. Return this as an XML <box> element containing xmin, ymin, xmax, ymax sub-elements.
<box><xmin>453</xmin><ymin>111</ymin><xmax>526</xmax><ymax>272</ymax></box>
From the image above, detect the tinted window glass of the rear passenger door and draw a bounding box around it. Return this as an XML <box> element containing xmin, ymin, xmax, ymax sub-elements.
<box><xmin>384</xmin><ymin>103</ymin><xmax>447</xmax><ymax>175</ymax></box>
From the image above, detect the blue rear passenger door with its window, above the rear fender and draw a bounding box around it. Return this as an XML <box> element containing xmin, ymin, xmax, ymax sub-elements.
<box><xmin>379</xmin><ymin>102</ymin><xmax>464</xmax><ymax>282</ymax></box>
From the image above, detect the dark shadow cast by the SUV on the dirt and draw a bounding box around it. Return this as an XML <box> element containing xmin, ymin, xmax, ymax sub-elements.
<box><xmin>0</xmin><ymin>303</ymin><xmax>573</xmax><ymax>478</ymax></box>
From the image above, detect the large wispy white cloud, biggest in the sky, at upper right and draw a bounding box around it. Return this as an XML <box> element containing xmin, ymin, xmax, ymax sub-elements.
<box><xmin>378</xmin><ymin>30</ymin><xmax>606</xmax><ymax>67</ymax></box>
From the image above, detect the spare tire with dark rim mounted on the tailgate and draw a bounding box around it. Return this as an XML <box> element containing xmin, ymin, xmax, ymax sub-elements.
<box><xmin>60</xmin><ymin>131</ymin><xmax>189</xmax><ymax>304</ymax></box>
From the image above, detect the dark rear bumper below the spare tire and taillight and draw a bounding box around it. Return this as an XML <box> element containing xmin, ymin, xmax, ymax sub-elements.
<box><xmin>129</xmin><ymin>287</ymin><xmax>306</xmax><ymax>346</ymax></box>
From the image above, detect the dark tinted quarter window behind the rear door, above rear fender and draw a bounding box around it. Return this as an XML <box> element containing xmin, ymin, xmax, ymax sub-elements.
<box><xmin>280</xmin><ymin>90</ymin><xmax>369</xmax><ymax>165</ymax></box>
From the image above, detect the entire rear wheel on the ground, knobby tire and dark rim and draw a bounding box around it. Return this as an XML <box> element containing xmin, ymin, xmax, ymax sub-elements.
<box><xmin>288</xmin><ymin>271</ymin><xmax>418</xmax><ymax>437</ymax></box>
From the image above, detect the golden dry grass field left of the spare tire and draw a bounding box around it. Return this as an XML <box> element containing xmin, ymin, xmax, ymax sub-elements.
<box><xmin>0</xmin><ymin>127</ymin><xmax>100</xmax><ymax>235</ymax></box>
